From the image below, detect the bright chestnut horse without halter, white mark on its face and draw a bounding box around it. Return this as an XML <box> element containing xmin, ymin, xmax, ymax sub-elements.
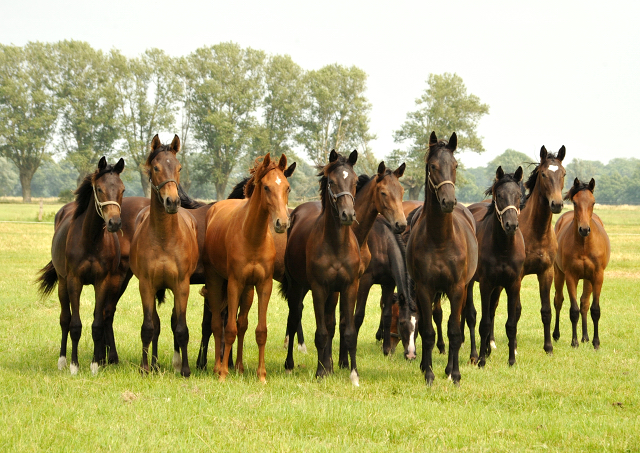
<box><xmin>203</xmin><ymin>154</ymin><xmax>291</xmax><ymax>382</ymax></box>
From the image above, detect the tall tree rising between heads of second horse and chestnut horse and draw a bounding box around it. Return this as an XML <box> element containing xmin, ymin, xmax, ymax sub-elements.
<box><xmin>187</xmin><ymin>42</ymin><xmax>265</xmax><ymax>199</ymax></box>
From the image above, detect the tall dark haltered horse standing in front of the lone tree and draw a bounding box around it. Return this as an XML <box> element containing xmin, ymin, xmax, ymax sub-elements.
<box><xmin>407</xmin><ymin>132</ymin><xmax>478</xmax><ymax>385</ymax></box>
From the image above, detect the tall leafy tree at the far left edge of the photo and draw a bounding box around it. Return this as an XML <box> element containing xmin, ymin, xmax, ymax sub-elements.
<box><xmin>0</xmin><ymin>42</ymin><xmax>59</xmax><ymax>203</ymax></box>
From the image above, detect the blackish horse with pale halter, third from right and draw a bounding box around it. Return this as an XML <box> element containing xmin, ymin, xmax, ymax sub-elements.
<box><xmin>462</xmin><ymin>167</ymin><xmax>525</xmax><ymax>367</ymax></box>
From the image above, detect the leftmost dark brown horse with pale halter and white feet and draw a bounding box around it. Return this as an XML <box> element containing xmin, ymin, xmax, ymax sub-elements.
<box><xmin>36</xmin><ymin>157</ymin><xmax>124</xmax><ymax>375</ymax></box>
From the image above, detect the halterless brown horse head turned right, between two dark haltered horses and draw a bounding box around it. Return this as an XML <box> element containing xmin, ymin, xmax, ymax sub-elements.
<box><xmin>374</xmin><ymin>162</ymin><xmax>407</xmax><ymax>233</ymax></box>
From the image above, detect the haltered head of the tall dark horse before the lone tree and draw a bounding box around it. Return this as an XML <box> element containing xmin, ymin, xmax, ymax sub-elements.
<box><xmin>426</xmin><ymin>131</ymin><xmax>458</xmax><ymax>213</ymax></box>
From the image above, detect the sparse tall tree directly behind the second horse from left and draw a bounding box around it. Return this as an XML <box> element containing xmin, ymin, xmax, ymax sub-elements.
<box><xmin>111</xmin><ymin>49</ymin><xmax>182</xmax><ymax>196</ymax></box>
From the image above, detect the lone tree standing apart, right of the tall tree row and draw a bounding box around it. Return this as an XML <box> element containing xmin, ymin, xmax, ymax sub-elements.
<box><xmin>390</xmin><ymin>73</ymin><xmax>489</xmax><ymax>199</ymax></box>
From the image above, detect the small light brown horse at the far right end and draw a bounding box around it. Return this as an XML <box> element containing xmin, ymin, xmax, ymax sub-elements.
<box><xmin>553</xmin><ymin>178</ymin><xmax>611</xmax><ymax>349</ymax></box>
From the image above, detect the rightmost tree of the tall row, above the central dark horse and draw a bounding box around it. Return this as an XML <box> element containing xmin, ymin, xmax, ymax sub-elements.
<box><xmin>296</xmin><ymin>64</ymin><xmax>375</xmax><ymax>165</ymax></box>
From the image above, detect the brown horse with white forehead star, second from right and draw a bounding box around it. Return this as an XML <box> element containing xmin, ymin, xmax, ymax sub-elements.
<box><xmin>467</xmin><ymin>146</ymin><xmax>566</xmax><ymax>354</ymax></box>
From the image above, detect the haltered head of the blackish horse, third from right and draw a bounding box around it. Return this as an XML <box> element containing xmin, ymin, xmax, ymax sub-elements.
<box><xmin>487</xmin><ymin>166</ymin><xmax>522</xmax><ymax>236</ymax></box>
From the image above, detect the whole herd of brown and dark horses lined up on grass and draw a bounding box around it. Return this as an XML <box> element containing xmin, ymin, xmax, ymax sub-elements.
<box><xmin>33</xmin><ymin>133</ymin><xmax>610</xmax><ymax>385</ymax></box>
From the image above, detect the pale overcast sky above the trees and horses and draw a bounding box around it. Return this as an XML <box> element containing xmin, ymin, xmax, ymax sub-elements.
<box><xmin>0</xmin><ymin>0</ymin><xmax>640</xmax><ymax>167</ymax></box>
